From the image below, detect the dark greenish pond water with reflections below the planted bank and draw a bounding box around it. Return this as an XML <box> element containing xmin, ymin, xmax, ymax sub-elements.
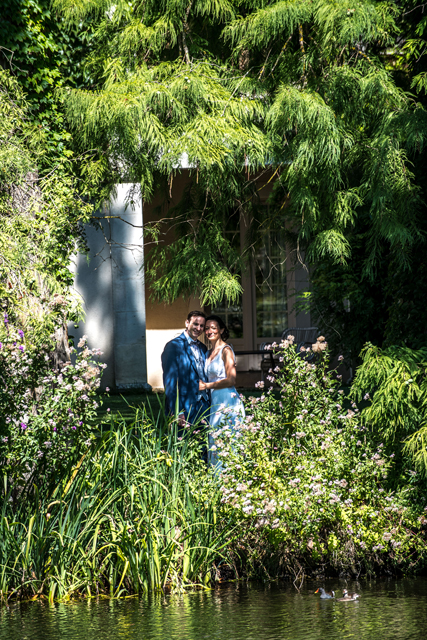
<box><xmin>0</xmin><ymin>578</ymin><xmax>427</xmax><ymax>640</ymax></box>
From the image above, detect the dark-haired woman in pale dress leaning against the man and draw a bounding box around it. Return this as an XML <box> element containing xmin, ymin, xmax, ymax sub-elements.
<box><xmin>199</xmin><ymin>316</ymin><xmax>245</xmax><ymax>467</ymax></box>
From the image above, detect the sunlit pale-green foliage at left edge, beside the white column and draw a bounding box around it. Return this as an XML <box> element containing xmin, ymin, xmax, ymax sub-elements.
<box><xmin>0</xmin><ymin>70</ymin><xmax>92</xmax><ymax>345</ymax></box>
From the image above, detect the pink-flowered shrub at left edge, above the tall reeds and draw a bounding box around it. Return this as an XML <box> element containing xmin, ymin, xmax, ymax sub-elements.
<box><xmin>0</xmin><ymin>314</ymin><xmax>106</xmax><ymax>478</ymax></box>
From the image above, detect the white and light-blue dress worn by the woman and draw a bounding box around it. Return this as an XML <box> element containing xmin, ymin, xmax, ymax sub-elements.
<box><xmin>205</xmin><ymin>344</ymin><xmax>245</xmax><ymax>467</ymax></box>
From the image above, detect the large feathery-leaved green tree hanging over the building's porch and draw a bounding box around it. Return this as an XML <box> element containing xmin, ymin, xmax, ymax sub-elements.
<box><xmin>46</xmin><ymin>0</ymin><xmax>427</xmax><ymax>356</ymax></box>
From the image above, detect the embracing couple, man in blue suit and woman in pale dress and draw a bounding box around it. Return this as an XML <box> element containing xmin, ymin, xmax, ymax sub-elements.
<box><xmin>162</xmin><ymin>311</ymin><xmax>245</xmax><ymax>464</ymax></box>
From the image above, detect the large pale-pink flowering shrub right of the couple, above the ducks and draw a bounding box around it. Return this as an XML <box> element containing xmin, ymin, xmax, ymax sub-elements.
<box><xmin>215</xmin><ymin>337</ymin><xmax>427</xmax><ymax>567</ymax></box>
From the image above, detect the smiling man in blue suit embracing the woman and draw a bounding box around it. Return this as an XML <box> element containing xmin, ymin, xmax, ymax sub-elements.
<box><xmin>162</xmin><ymin>311</ymin><xmax>210</xmax><ymax>426</ymax></box>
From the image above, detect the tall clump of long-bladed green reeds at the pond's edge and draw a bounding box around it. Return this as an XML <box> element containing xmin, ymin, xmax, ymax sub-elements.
<box><xmin>0</xmin><ymin>408</ymin><xmax>232</xmax><ymax>601</ymax></box>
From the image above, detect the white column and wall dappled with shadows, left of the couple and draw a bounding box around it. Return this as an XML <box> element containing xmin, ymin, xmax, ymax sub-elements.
<box><xmin>70</xmin><ymin>185</ymin><xmax>150</xmax><ymax>390</ymax></box>
